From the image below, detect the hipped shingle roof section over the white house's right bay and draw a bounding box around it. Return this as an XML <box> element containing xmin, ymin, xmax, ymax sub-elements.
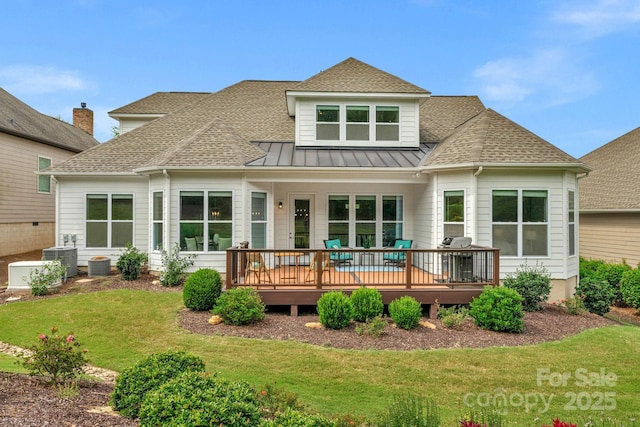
<box><xmin>424</xmin><ymin>109</ymin><xmax>580</xmax><ymax>167</ymax></box>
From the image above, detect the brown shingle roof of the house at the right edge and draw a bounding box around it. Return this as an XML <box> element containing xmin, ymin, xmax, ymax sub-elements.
<box><xmin>579</xmin><ymin>127</ymin><xmax>640</xmax><ymax>211</ymax></box>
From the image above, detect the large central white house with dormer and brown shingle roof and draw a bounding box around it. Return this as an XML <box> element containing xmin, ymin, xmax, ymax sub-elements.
<box><xmin>43</xmin><ymin>58</ymin><xmax>588</xmax><ymax>298</ymax></box>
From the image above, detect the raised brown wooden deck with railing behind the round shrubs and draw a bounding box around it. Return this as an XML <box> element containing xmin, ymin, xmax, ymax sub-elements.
<box><xmin>226</xmin><ymin>246</ymin><xmax>500</xmax><ymax>316</ymax></box>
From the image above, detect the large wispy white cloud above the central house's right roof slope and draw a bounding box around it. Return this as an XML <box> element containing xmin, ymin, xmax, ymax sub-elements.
<box><xmin>474</xmin><ymin>48</ymin><xmax>598</xmax><ymax>107</ymax></box>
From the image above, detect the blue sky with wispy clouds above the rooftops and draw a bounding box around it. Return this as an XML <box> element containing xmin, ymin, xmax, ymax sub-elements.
<box><xmin>0</xmin><ymin>0</ymin><xmax>640</xmax><ymax>157</ymax></box>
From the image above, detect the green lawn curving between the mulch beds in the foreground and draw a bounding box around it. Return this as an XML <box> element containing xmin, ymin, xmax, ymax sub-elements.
<box><xmin>0</xmin><ymin>290</ymin><xmax>640</xmax><ymax>426</ymax></box>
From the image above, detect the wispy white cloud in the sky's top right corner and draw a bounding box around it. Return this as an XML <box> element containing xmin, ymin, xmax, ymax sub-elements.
<box><xmin>551</xmin><ymin>0</ymin><xmax>640</xmax><ymax>38</ymax></box>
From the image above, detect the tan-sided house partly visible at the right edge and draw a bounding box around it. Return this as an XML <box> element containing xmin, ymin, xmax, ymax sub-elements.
<box><xmin>579</xmin><ymin>128</ymin><xmax>640</xmax><ymax>267</ymax></box>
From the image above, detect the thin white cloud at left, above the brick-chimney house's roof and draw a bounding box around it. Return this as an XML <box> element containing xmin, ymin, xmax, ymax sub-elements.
<box><xmin>0</xmin><ymin>65</ymin><xmax>91</xmax><ymax>94</ymax></box>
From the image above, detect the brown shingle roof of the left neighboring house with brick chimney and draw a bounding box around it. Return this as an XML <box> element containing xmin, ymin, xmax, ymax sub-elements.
<box><xmin>0</xmin><ymin>88</ymin><xmax>99</xmax><ymax>153</ymax></box>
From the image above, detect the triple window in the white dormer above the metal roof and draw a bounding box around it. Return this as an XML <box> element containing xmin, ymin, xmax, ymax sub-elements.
<box><xmin>316</xmin><ymin>104</ymin><xmax>400</xmax><ymax>143</ymax></box>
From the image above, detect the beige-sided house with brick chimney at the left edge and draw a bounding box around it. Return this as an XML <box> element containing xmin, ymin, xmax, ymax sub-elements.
<box><xmin>0</xmin><ymin>88</ymin><xmax>99</xmax><ymax>256</ymax></box>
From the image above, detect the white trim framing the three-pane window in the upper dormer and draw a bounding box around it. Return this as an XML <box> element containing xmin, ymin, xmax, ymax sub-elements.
<box><xmin>313</xmin><ymin>100</ymin><xmax>402</xmax><ymax>146</ymax></box>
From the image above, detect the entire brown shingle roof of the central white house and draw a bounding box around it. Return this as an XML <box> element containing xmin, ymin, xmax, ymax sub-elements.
<box><xmin>43</xmin><ymin>58</ymin><xmax>579</xmax><ymax>173</ymax></box>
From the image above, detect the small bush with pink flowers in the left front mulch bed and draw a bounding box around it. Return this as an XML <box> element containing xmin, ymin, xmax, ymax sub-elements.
<box><xmin>22</xmin><ymin>326</ymin><xmax>88</xmax><ymax>384</ymax></box>
